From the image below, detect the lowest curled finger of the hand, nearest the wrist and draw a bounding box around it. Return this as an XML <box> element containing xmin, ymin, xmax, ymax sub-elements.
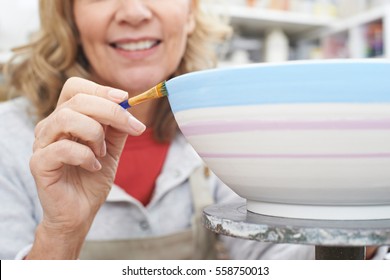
<box><xmin>30</xmin><ymin>139</ymin><xmax>102</xmax><ymax>179</ymax></box>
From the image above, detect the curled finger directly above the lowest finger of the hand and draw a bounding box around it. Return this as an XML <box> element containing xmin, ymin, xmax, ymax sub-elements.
<box><xmin>34</xmin><ymin>108</ymin><xmax>106</xmax><ymax>157</ymax></box>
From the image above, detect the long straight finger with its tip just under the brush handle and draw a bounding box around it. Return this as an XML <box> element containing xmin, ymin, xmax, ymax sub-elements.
<box><xmin>57</xmin><ymin>93</ymin><xmax>146</xmax><ymax>136</ymax></box>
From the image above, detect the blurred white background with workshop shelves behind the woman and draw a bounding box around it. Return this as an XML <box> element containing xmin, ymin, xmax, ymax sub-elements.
<box><xmin>0</xmin><ymin>0</ymin><xmax>390</xmax><ymax>71</ymax></box>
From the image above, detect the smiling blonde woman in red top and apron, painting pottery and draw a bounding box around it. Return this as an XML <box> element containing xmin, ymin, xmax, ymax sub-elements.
<box><xmin>0</xmin><ymin>0</ymin><xmax>313</xmax><ymax>259</ymax></box>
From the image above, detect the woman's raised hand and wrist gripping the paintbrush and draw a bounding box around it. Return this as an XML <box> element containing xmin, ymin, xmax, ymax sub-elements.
<box><xmin>28</xmin><ymin>78</ymin><xmax>145</xmax><ymax>259</ymax></box>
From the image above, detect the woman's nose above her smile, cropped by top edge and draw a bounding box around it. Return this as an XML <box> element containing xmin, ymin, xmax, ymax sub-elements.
<box><xmin>115</xmin><ymin>0</ymin><xmax>152</xmax><ymax>26</ymax></box>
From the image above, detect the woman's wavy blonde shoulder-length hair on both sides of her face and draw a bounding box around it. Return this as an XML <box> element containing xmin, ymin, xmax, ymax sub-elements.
<box><xmin>2</xmin><ymin>0</ymin><xmax>231</xmax><ymax>141</ymax></box>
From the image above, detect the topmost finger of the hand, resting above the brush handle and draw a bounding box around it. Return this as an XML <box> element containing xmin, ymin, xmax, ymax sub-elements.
<box><xmin>58</xmin><ymin>77</ymin><xmax>128</xmax><ymax>104</ymax></box>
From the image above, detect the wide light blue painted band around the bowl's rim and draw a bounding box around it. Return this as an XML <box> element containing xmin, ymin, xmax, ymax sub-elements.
<box><xmin>167</xmin><ymin>60</ymin><xmax>390</xmax><ymax>112</ymax></box>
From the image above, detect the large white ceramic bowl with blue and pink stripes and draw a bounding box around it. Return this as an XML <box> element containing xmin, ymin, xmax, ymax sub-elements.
<box><xmin>167</xmin><ymin>60</ymin><xmax>390</xmax><ymax>220</ymax></box>
